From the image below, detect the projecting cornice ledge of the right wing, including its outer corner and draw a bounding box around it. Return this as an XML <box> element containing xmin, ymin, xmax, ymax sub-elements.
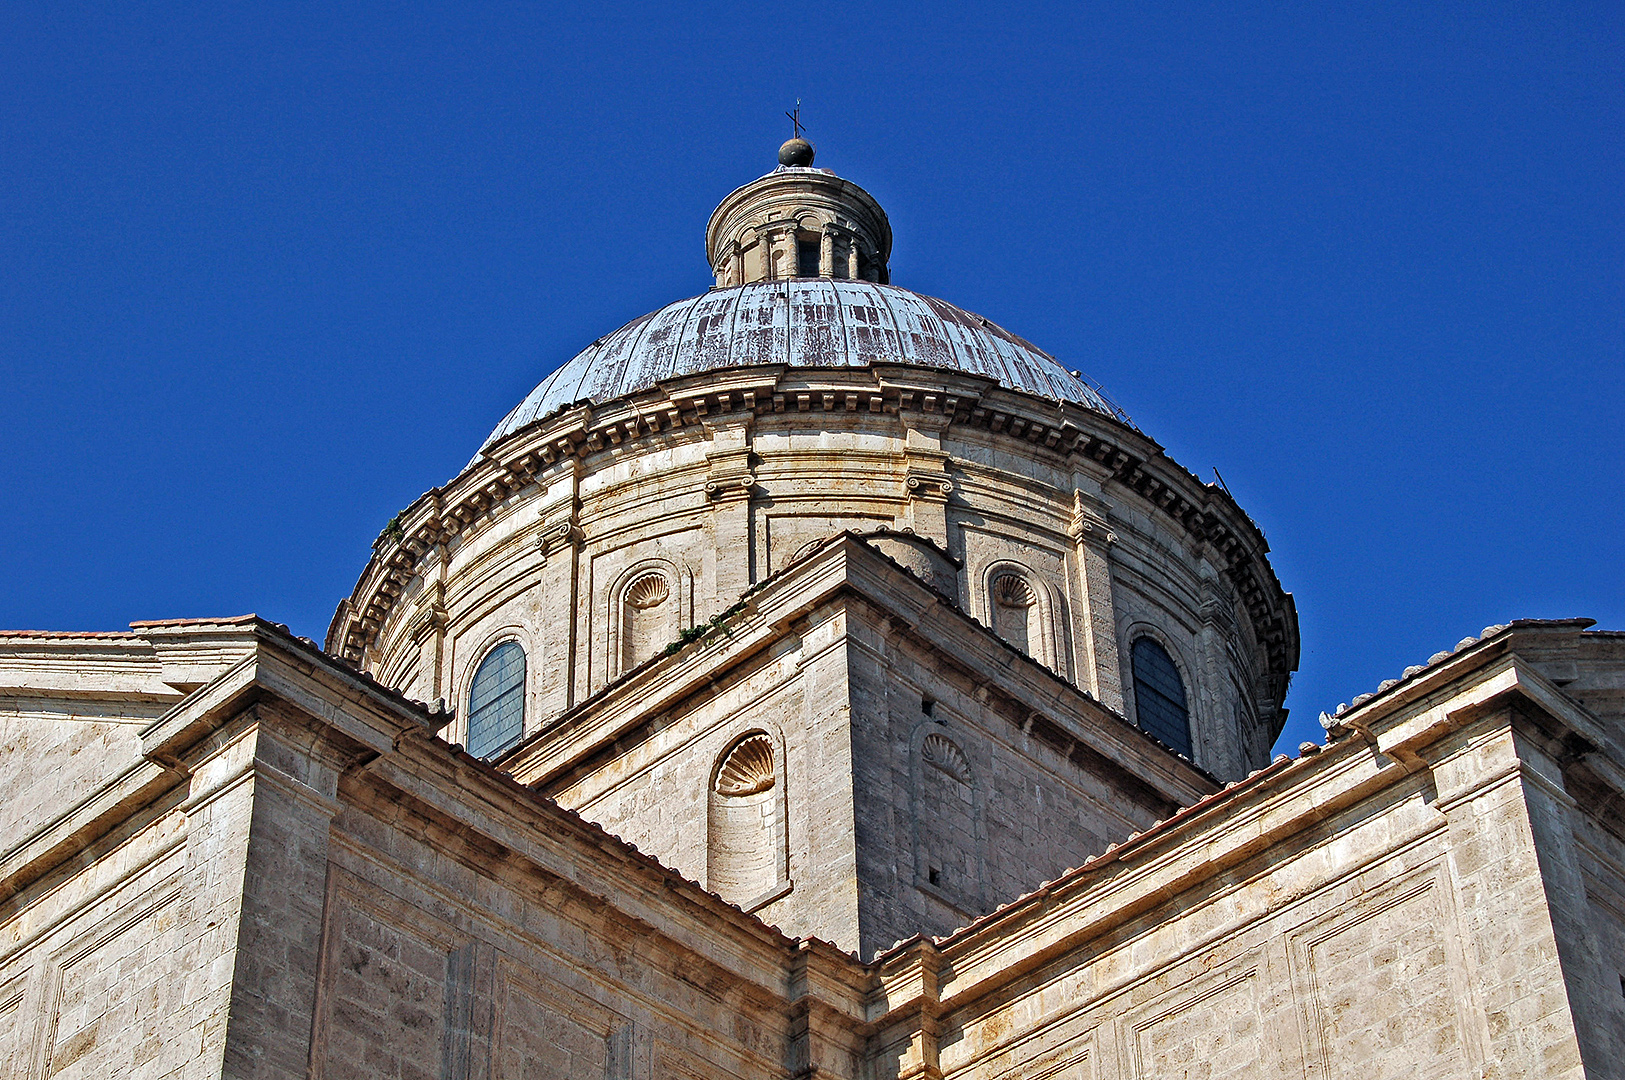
<box><xmin>869</xmin><ymin>624</ymin><xmax>1625</xmax><ymax>1026</ymax></box>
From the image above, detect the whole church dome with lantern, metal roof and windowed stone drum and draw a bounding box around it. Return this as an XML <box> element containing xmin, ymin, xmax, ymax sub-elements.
<box><xmin>328</xmin><ymin>145</ymin><xmax>1298</xmax><ymax>808</ymax></box>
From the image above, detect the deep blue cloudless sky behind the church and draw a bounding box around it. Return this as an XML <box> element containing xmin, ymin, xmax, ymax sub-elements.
<box><xmin>0</xmin><ymin>2</ymin><xmax>1625</xmax><ymax>747</ymax></box>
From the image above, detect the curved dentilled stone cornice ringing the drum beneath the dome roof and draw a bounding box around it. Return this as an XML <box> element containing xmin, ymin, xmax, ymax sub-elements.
<box><xmin>327</xmin><ymin>364</ymin><xmax>1298</xmax><ymax>714</ymax></box>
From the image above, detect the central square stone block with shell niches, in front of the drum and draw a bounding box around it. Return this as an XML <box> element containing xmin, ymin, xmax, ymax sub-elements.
<box><xmin>504</xmin><ymin>541</ymin><xmax>1211</xmax><ymax>957</ymax></box>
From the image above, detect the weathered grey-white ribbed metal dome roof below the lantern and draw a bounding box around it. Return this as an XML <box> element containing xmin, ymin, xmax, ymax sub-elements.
<box><xmin>481</xmin><ymin>278</ymin><xmax>1118</xmax><ymax>448</ymax></box>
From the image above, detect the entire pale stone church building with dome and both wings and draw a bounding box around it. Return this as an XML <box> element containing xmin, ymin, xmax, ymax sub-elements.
<box><xmin>0</xmin><ymin>141</ymin><xmax>1625</xmax><ymax>1080</ymax></box>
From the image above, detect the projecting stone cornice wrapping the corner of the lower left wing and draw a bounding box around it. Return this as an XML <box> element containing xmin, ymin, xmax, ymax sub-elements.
<box><xmin>0</xmin><ymin>610</ymin><xmax>873</xmax><ymax>1026</ymax></box>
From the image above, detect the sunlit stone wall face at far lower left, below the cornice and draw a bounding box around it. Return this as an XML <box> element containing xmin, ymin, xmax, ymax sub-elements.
<box><xmin>0</xmin><ymin>708</ymin><xmax>263</xmax><ymax>1080</ymax></box>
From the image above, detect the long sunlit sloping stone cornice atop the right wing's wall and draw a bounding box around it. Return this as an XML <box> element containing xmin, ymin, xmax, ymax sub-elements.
<box><xmin>869</xmin><ymin>623</ymin><xmax>1625</xmax><ymax>1022</ymax></box>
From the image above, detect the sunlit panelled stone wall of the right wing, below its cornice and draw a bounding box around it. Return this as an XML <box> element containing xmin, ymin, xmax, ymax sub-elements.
<box><xmin>886</xmin><ymin>718</ymin><xmax>1612</xmax><ymax>1080</ymax></box>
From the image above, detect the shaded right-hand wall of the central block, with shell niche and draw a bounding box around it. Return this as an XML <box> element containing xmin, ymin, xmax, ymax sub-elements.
<box><xmin>848</xmin><ymin>594</ymin><xmax>1173</xmax><ymax>957</ymax></box>
